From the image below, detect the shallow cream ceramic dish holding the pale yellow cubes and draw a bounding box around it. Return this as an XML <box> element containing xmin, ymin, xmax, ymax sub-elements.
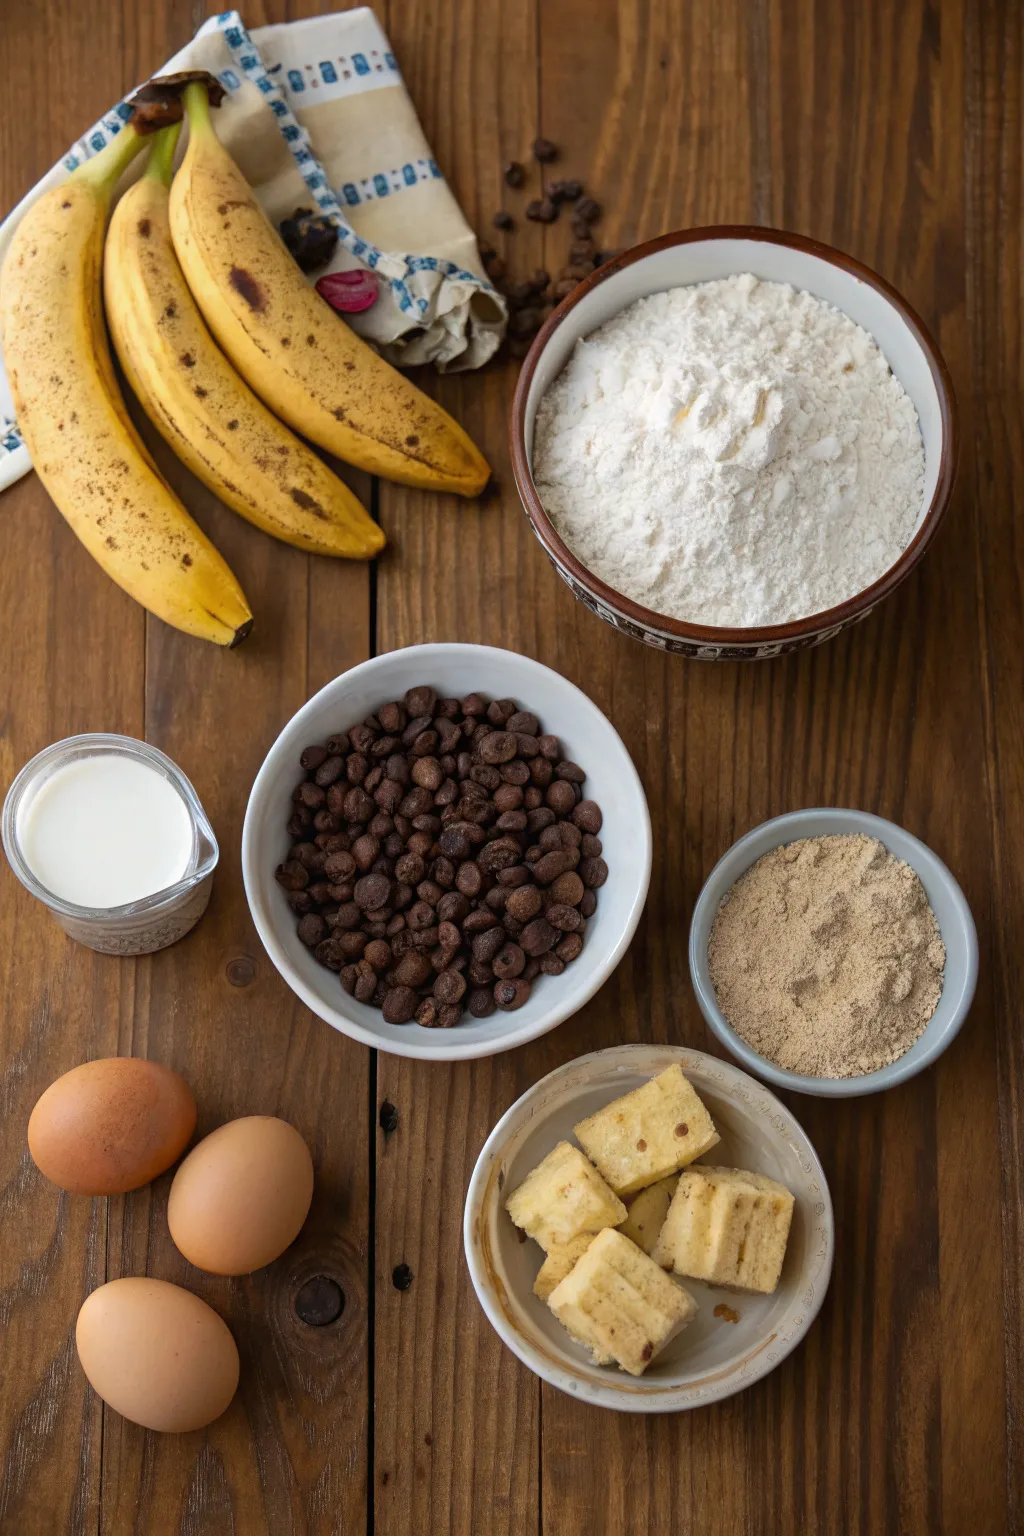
<box><xmin>464</xmin><ymin>1046</ymin><xmax>834</xmax><ymax>1413</ymax></box>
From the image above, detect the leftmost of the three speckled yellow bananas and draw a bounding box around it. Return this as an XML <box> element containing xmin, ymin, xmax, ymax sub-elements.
<box><xmin>0</xmin><ymin>123</ymin><xmax>252</xmax><ymax>645</ymax></box>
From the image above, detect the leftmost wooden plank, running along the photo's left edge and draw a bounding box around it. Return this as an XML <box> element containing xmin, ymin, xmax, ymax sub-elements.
<box><xmin>0</xmin><ymin>6</ymin><xmax>144</xmax><ymax>1531</ymax></box>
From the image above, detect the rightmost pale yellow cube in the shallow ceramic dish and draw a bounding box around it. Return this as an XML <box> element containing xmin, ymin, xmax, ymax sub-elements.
<box><xmin>652</xmin><ymin>1166</ymin><xmax>794</xmax><ymax>1295</ymax></box>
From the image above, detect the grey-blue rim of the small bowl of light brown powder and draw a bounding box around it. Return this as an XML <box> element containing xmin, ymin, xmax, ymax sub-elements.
<box><xmin>688</xmin><ymin>806</ymin><xmax>978</xmax><ymax>1098</ymax></box>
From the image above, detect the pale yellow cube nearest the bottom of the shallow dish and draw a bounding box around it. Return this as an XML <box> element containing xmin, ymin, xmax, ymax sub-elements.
<box><xmin>548</xmin><ymin>1229</ymin><xmax>697</xmax><ymax>1376</ymax></box>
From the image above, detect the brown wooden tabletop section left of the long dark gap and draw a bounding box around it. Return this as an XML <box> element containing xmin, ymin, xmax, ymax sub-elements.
<box><xmin>0</xmin><ymin>6</ymin><xmax>372</xmax><ymax>1536</ymax></box>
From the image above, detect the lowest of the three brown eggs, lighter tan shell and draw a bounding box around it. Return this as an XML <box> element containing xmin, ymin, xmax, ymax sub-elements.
<box><xmin>75</xmin><ymin>1278</ymin><xmax>238</xmax><ymax>1435</ymax></box>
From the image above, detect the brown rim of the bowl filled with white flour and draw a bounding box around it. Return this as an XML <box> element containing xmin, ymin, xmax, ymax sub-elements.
<box><xmin>508</xmin><ymin>224</ymin><xmax>960</xmax><ymax>647</ymax></box>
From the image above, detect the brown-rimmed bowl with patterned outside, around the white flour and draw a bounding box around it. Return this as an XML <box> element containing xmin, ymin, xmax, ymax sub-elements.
<box><xmin>510</xmin><ymin>224</ymin><xmax>958</xmax><ymax>660</ymax></box>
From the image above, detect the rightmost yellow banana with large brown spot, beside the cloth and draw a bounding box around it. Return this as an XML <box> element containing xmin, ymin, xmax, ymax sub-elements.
<box><xmin>170</xmin><ymin>84</ymin><xmax>490</xmax><ymax>496</ymax></box>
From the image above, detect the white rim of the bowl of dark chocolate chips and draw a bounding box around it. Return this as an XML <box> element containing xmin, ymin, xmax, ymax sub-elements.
<box><xmin>241</xmin><ymin>641</ymin><xmax>654</xmax><ymax>1061</ymax></box>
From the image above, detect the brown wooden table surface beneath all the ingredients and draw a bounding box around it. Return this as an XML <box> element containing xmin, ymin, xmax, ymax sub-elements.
<box><xmin>0</xmin><ymin>0</ymin><xmax>1024</xmax><ymax>1536</ymax></box>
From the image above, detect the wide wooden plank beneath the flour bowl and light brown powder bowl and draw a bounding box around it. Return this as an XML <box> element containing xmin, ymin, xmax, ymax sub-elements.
<box><xmin>528</xmin><ymin>3</ymin><xmax>1004</xmax><ymax>1536</ymax></box>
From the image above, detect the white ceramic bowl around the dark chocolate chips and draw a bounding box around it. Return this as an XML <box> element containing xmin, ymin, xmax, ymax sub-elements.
<box><xmin>241</xmin><ymin>644</ymin><xmax>651</xmax><ymax>1061</ymax></box>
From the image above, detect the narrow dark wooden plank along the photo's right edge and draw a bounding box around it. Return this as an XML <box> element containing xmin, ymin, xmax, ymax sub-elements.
<box><xmin>949</xmin><ymin>3</ymin><xmax>1024</xmax><ymax>1530</ymax></box>
